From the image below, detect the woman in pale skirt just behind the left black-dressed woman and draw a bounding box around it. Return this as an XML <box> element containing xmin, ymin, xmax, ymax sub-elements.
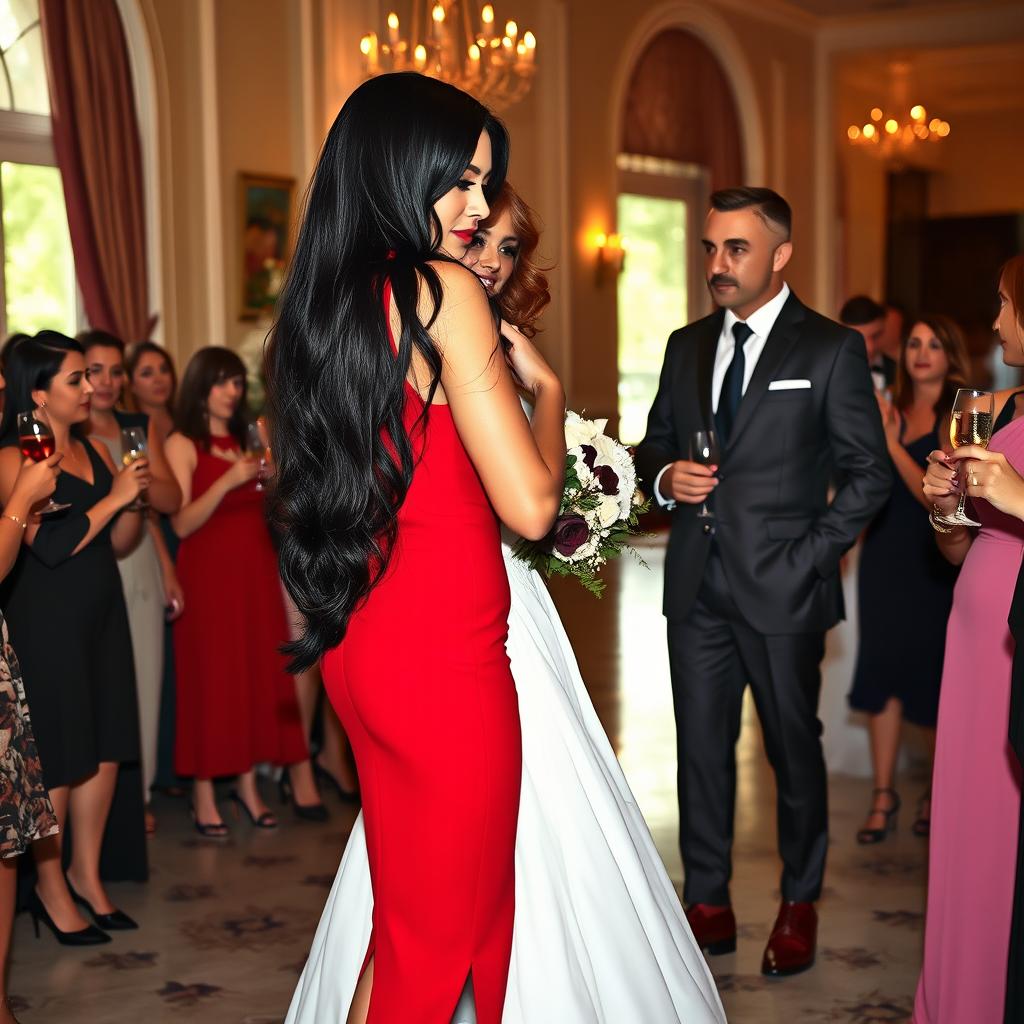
<box><xmin>78</xmin><ymin>331</ymin><xmax>184</xmax><ymax>834</ymax></box>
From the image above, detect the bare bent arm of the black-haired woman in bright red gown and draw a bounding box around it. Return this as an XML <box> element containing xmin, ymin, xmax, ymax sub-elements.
<box><xmin>421</xmin><ymin>263</ymin><xmax>565</xmax><ymax>541</ymax></box>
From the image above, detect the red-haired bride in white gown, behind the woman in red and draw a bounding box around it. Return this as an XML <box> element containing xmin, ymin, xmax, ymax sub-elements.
<box><xmin>286</xmin><ymin>185</ymin><xmax>725</xmax><ymax>1024</ymax></box>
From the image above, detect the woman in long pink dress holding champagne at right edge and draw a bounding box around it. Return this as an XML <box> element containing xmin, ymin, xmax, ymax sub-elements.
<box><xmin>913</xmin><ymin>257</ymin><xmax>1024</xmax><ymax>1024</ymax></box>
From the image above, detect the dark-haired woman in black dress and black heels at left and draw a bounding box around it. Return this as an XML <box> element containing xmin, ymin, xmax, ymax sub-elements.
<box><xmin>0</xmin><ymin>331</ymin><xmax>150</xmax><ymax>944</ymax></box>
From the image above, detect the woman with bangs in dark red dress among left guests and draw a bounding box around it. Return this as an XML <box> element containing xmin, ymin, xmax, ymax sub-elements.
<box><xmin>166</xmin><ymin>348</ymin><xmax>311</xmax><ymax>838</ymax></box>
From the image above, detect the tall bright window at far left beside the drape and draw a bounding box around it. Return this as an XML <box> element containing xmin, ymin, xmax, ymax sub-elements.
<box><xmin>0</xmin><ymin>0</ymin><xmax>80</xmax><ymax>337</ymax></box>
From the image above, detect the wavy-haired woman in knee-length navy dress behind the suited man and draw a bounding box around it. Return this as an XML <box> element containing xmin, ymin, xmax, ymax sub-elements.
<box><xmin>849</xmin><ymin>316</ymin><xmax>968</xmax><ymax>844</ymax></box>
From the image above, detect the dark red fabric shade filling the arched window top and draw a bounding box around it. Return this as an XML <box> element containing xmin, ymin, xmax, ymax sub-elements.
<box><xmin>622</xmin><ymin>29</ymin><xmax>743</xmax><ymax>188</ymax></box>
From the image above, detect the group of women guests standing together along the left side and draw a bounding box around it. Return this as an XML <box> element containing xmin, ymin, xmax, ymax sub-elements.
<box><xmin>0</xmin><ymin>331</ymin><xmax>358</xmax><ymax>1024</ymax></box>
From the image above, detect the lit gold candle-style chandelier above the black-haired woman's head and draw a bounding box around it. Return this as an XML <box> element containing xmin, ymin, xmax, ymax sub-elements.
<box><xmin>359</xmin><ymin>0</ymin><xmax>537</xmax><ymax>111</ymax></box>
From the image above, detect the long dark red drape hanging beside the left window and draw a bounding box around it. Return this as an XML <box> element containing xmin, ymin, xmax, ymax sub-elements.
<box><xmin>39</xmin><ymin>0</ymin><xmax>150</xmax><ymax>343</ymax></box>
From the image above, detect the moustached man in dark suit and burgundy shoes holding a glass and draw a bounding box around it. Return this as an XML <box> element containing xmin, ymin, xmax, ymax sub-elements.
<box><xmin>637</xmin><ymin>188</ymin><xmax>891</xmax><ymax>976</ymax></box>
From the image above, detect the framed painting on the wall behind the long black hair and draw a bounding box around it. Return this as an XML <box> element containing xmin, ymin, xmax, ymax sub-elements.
<box><xmin>239</xmin><ymin>172</ymin><xmax>295</xmax><ymax>319</ymax></box>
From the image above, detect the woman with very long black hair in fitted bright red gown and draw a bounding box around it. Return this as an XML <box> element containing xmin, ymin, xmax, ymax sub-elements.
<box><xmin>267</xmin><ymin>74</ymin><xmax>565</xmax><ymax>1024</ymax></box>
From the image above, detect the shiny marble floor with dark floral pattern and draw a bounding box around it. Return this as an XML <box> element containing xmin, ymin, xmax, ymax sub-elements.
<box><xmin>10</xmin><ymin>542</ymin><xmax>927</xmax><ymax>1024</ymax></box>
